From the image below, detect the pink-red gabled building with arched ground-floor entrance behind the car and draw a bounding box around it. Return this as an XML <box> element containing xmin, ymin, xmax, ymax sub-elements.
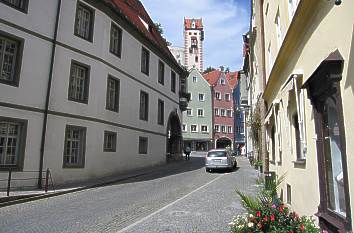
<box><xmin>203</xmin><ymin>70</ymin><xmax>234</xmax><ymax>149</ymax></box>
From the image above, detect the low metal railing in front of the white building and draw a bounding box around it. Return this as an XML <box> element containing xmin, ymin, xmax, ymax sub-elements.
<box><xmin>0</xmin><ymin>168</ymin><xmax>55</xmax><ymax>196</ymax></box>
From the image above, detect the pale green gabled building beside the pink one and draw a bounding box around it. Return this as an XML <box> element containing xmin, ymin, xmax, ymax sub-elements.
<box><xmin>182</xmin><ymin>68</ymin><xmax>213</xmax><ymax>151</ymax></box>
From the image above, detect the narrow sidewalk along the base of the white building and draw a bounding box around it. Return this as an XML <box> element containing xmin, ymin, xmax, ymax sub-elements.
<box><xmin>0</xmin><ymin>160</ymin><xmax>184</xmax><ymax>208</ymax></box>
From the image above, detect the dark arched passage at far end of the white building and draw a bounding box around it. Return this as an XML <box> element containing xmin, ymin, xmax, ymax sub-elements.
<box><xmin>166</xmin><ymin>110</ymin><xmax>183</xmax><ymax>160</ymax></box>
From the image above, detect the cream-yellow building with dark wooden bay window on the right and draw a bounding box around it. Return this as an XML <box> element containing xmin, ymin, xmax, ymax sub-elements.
<box><xmin>258</xmin><ymin>0</ymin><xmax>354</xmax><ymax>232</ymax></box>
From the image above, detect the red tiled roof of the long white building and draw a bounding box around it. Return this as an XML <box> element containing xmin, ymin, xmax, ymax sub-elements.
<box><xmin>104</xmin><ymin>0</ymin><xmax>177</xmax><ymax>68</ymax></box>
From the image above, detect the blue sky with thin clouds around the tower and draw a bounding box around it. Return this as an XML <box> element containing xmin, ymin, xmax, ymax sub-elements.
<box><xmin>141</xmin><ymin>0</ymin><xmax>250</xmax><ymax>71</ymax></box>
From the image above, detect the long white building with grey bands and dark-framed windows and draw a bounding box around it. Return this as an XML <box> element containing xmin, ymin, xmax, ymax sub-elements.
<box><xmin>0</xmin><ymin>0</ymin><xmax>187</xmax><ymax>185</ymax></box>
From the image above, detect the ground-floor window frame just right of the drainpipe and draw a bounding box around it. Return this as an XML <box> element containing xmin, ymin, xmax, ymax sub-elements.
<box><xmin>63</xmin><ymin>125</ymin><xmax>87</xmax><ymax>168</ymax></box>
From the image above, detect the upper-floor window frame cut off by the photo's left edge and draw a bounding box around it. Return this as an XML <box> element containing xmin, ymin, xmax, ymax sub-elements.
<box><xmin>0</xmin><ymin>30</ymin><xmax>25</xmax><ymax>87</ymax></box>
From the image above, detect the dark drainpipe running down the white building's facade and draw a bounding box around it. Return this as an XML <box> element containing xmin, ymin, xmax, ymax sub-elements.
<box><xmin>38</xmin><ymin>0</ymin><xmax>61</xmax><ymax>188</ymax></box>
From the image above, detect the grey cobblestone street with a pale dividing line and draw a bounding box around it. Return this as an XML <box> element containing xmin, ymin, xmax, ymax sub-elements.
<box><xmin>0</xmin><ymin>156</ymin><xmax>257</xmax><ymax>233</ymax></box>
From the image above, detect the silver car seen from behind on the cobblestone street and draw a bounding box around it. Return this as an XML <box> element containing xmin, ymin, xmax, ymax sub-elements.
<box><xmin>205</xmin><ymin>149</ymin><xmax>237</xmax><ymax>172</ymax></box>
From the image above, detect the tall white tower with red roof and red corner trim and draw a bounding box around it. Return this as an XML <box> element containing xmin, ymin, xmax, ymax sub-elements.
<box><xmin>184</xmin><ymin>18</ymin><xmax>204</xmax><ymax>72</ymax></box>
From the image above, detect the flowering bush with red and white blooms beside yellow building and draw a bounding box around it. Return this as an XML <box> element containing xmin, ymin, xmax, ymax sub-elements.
<box><xmin>229</xmin><ymin>175</ymin><xmax>326</xmax><ymax>233</ymax></box>
